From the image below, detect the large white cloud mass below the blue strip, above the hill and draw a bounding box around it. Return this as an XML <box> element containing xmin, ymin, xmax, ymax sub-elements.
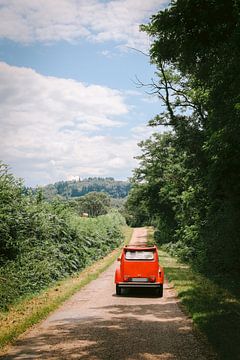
<box><xmin>0</xmin><ymin>63</ymin><xmax>141</xmax><ymax>184</ymax></box>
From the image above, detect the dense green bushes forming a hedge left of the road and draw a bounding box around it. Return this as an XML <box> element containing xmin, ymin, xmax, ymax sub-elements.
<box><xmin>0</xmin><ymin>164</ymin><xmax>124</xmax><ymax>310</ymax></box>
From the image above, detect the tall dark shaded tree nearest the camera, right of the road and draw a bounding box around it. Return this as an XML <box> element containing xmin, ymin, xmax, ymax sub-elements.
<box><xmin>129</xmin><ymin>0</ymin><xmax>240</xmax><ymax>273</ymax></box>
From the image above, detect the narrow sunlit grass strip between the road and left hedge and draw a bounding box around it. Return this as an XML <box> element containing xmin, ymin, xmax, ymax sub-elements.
<box><xmin>0</xmin><ymin>226</ymin><xmax>133</xmax><ymax>353</ymax></box>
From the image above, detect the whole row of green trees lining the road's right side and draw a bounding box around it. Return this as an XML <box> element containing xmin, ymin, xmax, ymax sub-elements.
<box><xmin>127</xmin><ymin>0</ymin><xmax>240</xmax><ymax>277</ymax></box>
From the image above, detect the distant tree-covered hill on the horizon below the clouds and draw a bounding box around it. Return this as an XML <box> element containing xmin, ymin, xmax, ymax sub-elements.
<box><xmin>38</xmin><ymin>177</ymin><xmax>130</xmax><ymax>200</ymax></box>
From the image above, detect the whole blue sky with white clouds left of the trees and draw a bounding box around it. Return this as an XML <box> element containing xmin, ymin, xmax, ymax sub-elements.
<box><xmin>0</xmin><ymin>0</ymin><xmax>167</xmax><ymax>186</ymax></box>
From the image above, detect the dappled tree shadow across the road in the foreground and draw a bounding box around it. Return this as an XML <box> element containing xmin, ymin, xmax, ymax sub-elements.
<box><xmin>1</xmin><ymin>301</ymin><xmax>214</xmax><ymax>360</ymax></box>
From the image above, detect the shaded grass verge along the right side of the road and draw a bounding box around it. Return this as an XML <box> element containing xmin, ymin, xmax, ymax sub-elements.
<box><xmin>159</xmin><ymin>249</ymin><xmax>240</xmax><ymax>360</ymax></box>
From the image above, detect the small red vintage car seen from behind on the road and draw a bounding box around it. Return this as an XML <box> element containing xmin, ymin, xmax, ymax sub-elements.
<box><xmin>115</xmin><ymin>246</ymin><xmax>164</xmax><ymax>297</ymax></box>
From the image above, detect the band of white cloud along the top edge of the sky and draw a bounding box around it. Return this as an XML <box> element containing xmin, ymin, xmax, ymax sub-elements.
<box><xmin>0</xmin><ymin>0</ymin><xmax>166</xmax><ymax>49</ymax></box>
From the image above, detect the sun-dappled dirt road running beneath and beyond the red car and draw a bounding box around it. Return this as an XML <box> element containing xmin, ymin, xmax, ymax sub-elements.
<box><xmin>2</xmin><ymin>229</ymin><xmax>214</xmax><ymax>360</ymax></box>
